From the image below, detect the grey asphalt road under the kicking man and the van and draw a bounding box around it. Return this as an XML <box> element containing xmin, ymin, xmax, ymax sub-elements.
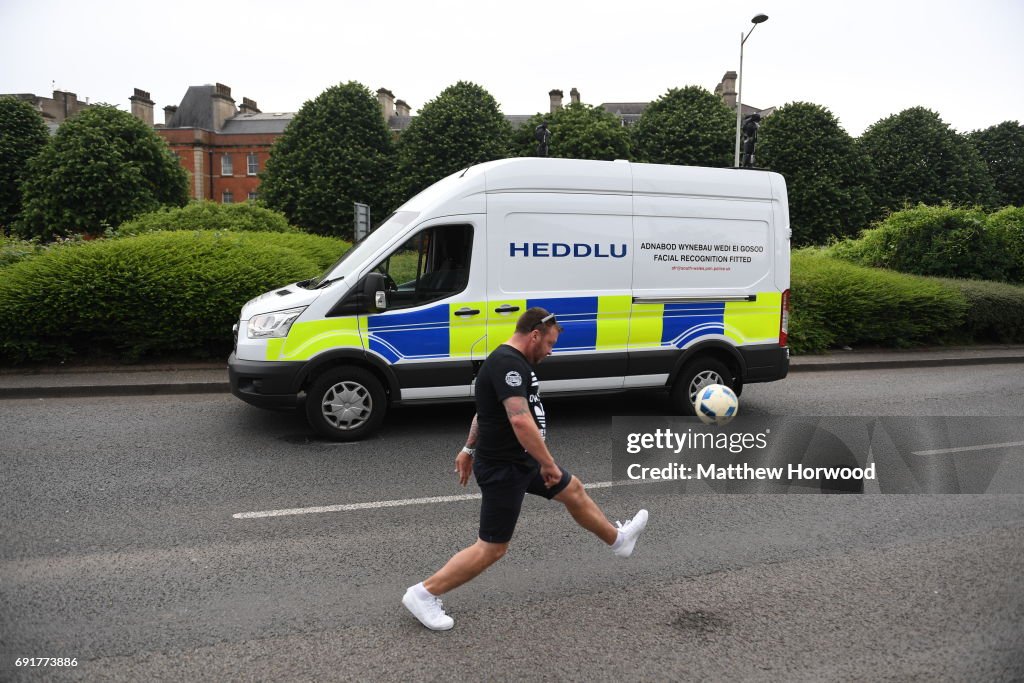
<box><xmin>0</xmin><ymin>365</ymin><xmax>1024</xmax><ymax>681</ymax></box>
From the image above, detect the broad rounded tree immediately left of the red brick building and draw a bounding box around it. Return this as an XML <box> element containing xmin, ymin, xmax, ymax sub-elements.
<box><xmin>16</xmin><ymin>104</ymin><xmax>188</xmax><ymax>240</ymax></box>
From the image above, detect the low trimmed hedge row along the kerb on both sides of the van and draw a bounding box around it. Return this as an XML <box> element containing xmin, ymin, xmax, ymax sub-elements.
<box><xmin>0</xmin><ymin>231</ymin><xmax>1024</xmax><ymax>362</ymax></box>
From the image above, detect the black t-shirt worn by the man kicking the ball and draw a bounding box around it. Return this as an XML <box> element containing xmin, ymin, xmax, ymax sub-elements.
<box><xmin>476</xmin><ymin>344</ymin><xmax>548</xmax><ymax>463</ymax></box>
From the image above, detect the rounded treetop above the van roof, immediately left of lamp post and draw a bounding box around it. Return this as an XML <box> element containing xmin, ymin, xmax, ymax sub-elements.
<box><xmin>633</xmin><ymin>85</ymin><xmax>736</xmax><ymax>167</ymax></box>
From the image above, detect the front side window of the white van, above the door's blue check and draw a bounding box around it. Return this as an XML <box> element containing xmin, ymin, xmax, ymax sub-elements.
<box><xmin>374</xmin><ymin>225</ymin><xmax>473</xmax><ymax>310</ymax></box>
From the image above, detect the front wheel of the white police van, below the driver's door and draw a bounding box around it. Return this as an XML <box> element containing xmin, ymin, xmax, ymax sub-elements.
<box><xmin>306</xmin><ymin>367</ymin><xmax>387</xmax><ymax>441</ymax></box>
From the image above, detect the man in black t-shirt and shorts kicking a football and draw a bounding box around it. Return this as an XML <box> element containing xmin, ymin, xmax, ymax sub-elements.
<box><xmin>401</xmin><ymin>308</ymin><xmax>647</xmax><ymax>631</ymax></box>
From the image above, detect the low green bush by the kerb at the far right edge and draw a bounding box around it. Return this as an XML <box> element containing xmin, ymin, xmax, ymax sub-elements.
<box><xmin>940</xmin><ymin>280</ymin><xmax>1024</xmax><ymax>344</ymax></box>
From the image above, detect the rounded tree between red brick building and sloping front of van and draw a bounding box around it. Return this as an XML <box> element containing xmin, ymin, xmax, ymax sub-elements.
<box><xmin>259</xmin><ymin>81</ymin><xmax>394</xmax><ymax>239</ymax></box>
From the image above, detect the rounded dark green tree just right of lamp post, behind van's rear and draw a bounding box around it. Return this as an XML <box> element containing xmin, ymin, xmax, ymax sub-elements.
<box><xmin>757</xmin><ymin>102</ymin><xmax>873</xmax><ymax>247</ymax></box>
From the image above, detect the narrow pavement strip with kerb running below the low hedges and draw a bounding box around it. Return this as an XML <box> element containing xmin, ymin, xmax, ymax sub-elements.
<box><xmin>0</xmin><ymin>345</ymin><xmax>1024</xmax><ymax>399</ymax></box>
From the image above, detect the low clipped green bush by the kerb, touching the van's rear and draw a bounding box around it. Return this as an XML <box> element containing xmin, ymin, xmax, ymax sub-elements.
<box><xmin>790</xmin><ymin>249</ymin><xmax>968</xmax><ymax>353</ymax></box>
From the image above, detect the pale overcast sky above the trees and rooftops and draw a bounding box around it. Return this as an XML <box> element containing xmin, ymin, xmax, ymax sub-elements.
<box><xmin>0</xmin><ymin>0</ymin><xmax>1024</xmax><ymax>135</ymax></box>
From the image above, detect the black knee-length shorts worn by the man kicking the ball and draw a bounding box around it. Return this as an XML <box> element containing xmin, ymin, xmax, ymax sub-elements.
<box><xmin>473</xmin><ymin>458</ymin><xmax>572</xmax><ymax>543</ymax></box>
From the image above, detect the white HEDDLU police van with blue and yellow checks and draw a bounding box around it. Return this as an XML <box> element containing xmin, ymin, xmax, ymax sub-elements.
<box><xmin>228</xmin><ymin>159</ymin><xmax>791</xmax><ymax>440</ymax></box>
